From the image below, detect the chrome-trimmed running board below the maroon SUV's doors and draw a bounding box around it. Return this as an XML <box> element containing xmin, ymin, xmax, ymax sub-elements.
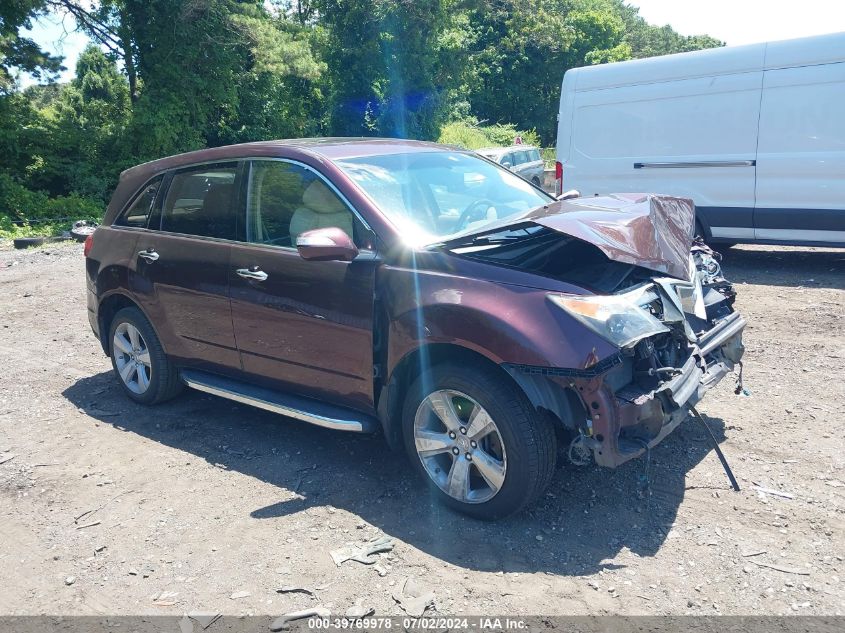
<box><xmin>181</xmin><ymin>369</ymin><xmax>381</xmax><ymax>433</ymax></box>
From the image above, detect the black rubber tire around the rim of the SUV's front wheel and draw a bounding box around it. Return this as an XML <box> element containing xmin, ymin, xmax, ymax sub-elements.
<box><xmin>402</xmin><ymin>364</ymin><xmax>557</xmax><ymax>520</ymax></box>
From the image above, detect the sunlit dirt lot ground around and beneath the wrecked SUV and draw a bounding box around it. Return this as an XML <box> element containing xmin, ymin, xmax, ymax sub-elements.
<box><xmin>0</xmin><ymin>239</ymin><xmax>845</xmax><ymax>615</ymax></box>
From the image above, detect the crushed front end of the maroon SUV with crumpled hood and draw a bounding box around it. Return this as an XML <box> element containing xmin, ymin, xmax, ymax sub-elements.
<box><xmin>442</xmin><ymin>194</ymin><xmax>745</xmax><ymax>467</ymax></box>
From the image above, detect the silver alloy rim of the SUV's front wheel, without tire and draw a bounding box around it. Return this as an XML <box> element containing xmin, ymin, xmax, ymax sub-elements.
<box><xmin>414</xmin><ymin>389</ymin><xmax>507</xmax><ymax>503</ymax></box>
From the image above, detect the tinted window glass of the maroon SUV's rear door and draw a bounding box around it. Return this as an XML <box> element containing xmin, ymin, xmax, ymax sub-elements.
<box><xmin>161</xmin><ymin>164</ymin><xmax>238</xmax><ymax>240</ymax></box>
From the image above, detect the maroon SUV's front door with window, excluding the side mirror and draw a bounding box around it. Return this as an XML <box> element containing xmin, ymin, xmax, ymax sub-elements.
<box><xmin>229</xmin><ymin>160</ymin><xmax>378</xmax><ymax>412</ymax></box>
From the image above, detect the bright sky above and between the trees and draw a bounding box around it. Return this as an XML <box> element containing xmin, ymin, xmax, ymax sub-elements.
<box><xmin>14</xmin><ymin>0</ymin><xmax>845</xmax><ymax>87</ymax></box>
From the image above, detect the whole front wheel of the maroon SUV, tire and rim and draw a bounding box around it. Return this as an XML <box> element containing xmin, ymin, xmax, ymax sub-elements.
<box><xmin>403</xmin><ymin>365</ymin><xmax>557</xmax><ymax>519</ymax></box>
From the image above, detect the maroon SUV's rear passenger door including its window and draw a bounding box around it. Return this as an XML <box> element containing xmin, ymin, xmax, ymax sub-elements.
<box><xmin>133</xmin><ymin>162</ymin><xmax>240</xmax><ymax>373</ymax></box>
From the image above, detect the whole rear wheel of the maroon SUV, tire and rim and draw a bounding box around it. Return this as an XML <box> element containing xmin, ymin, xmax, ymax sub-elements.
<box><xmin>109</xmin><ymin>308</ymin><xmax>182</xmax><ymax>404</ymax></box>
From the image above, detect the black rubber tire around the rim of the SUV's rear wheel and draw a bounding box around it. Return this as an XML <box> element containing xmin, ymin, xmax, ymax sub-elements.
<box><xmin>108</xmin><ymin>308</ymin><xmax>183</xmax><ymax>405</ymax></box>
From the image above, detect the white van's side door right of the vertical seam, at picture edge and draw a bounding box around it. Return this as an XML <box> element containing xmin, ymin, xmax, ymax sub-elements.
<box><xmin>754</xmin><ymin>59</ymin><xmax>845</xmax><ymax>243</ymax></box>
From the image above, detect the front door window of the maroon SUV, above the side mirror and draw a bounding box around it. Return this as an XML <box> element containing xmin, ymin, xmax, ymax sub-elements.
<box><xmin>246</xmin><ymin>161</ymin><xmax>372</xmax><ymax>248</ymax></box>
